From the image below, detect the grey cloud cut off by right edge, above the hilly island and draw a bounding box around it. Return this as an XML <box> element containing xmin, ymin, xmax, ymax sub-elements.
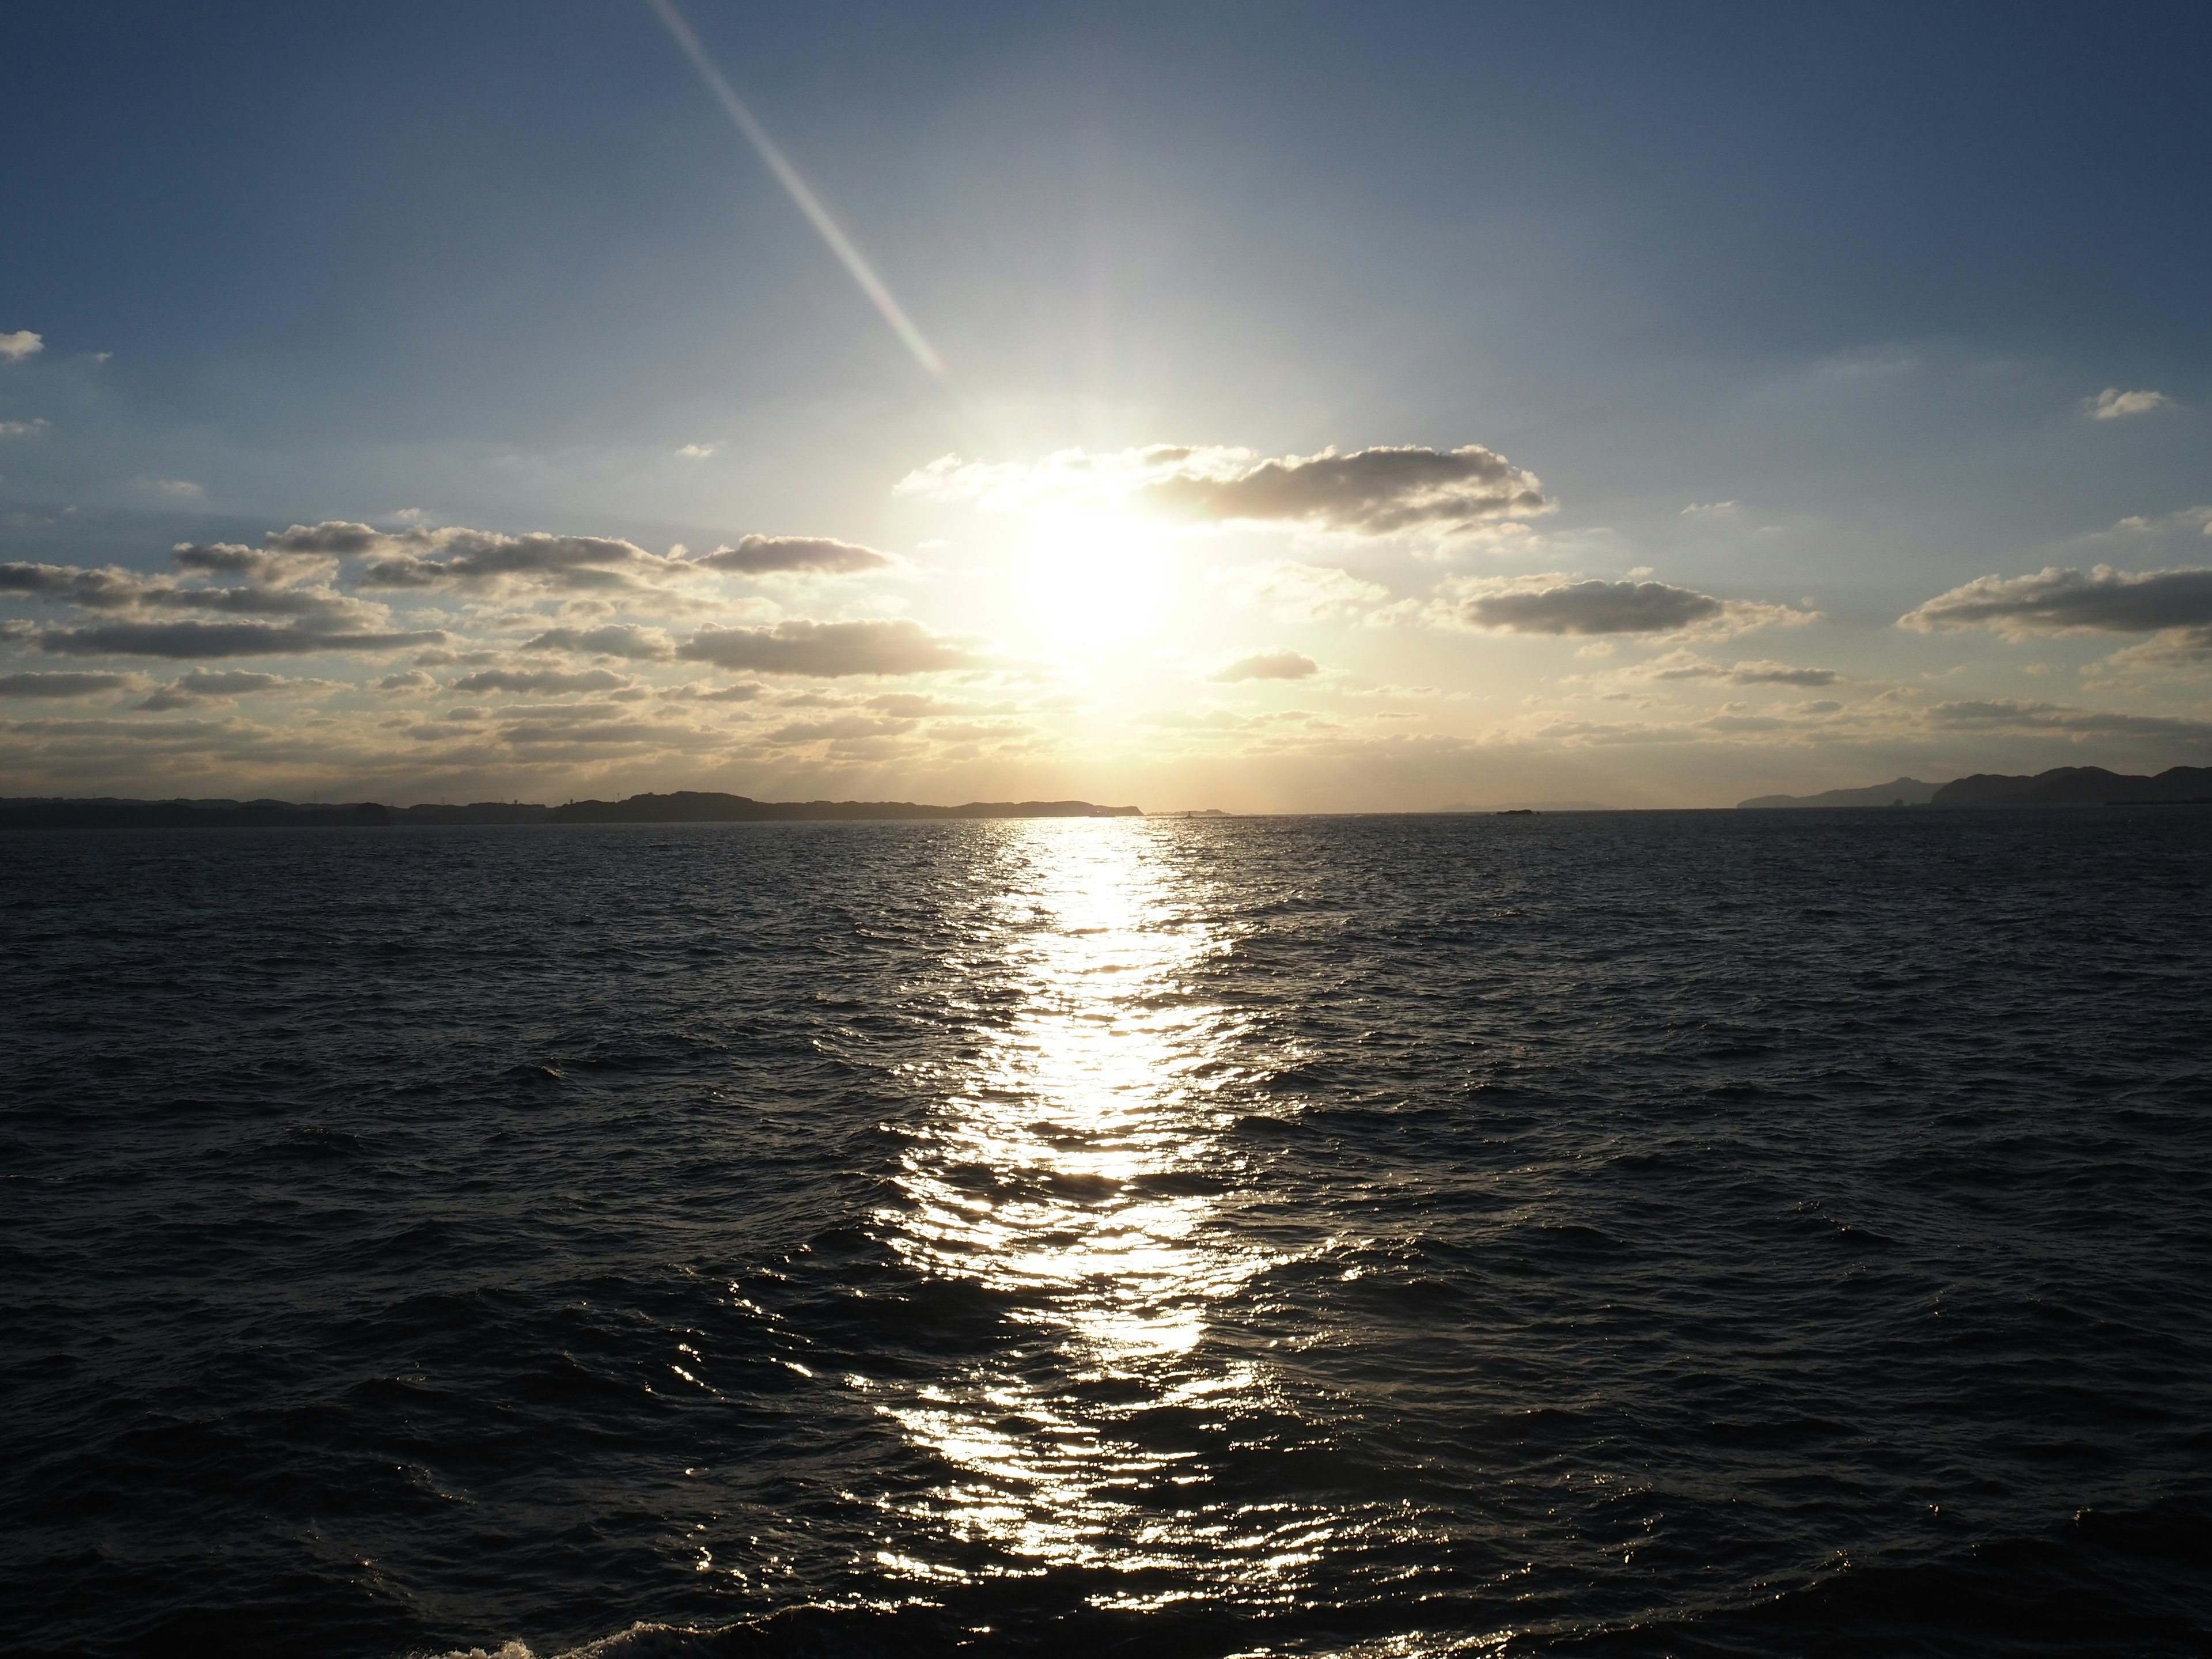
<box><xmin>1898</xmin><ymin>564</ymin><xmax>2212</xmax><ymax>664</ymax></box>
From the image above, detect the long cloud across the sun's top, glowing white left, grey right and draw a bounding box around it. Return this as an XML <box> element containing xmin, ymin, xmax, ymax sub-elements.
<box><xmin>898</xmin><ymin>445</ymin><xmax>1555</xmax><ymax>535</ymax></box>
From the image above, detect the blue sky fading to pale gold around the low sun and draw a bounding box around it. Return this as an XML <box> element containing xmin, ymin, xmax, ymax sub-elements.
<box><xmin>0</xmin><ymin>0</ymin><xmax>2212</xmax><ymax>808</ymax></box>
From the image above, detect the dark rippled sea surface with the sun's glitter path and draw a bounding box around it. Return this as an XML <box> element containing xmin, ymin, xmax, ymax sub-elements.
<box><xmin>0</xmin><ymin>809</ymin><xmax>2212</xmax><ymax>1659</ymax></box>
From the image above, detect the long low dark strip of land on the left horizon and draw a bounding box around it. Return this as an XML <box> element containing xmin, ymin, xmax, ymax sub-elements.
<box><xmin>0</xmin><ymin>790</ymin><xmax>1143</xmax><ymax>830</ymax></box>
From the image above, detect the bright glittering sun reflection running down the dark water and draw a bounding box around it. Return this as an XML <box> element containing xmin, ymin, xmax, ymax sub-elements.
<box><xmin>878</xmin><ymin>823</ymin><xmax>1320</xmax><ymax>1606</ymax></box>
